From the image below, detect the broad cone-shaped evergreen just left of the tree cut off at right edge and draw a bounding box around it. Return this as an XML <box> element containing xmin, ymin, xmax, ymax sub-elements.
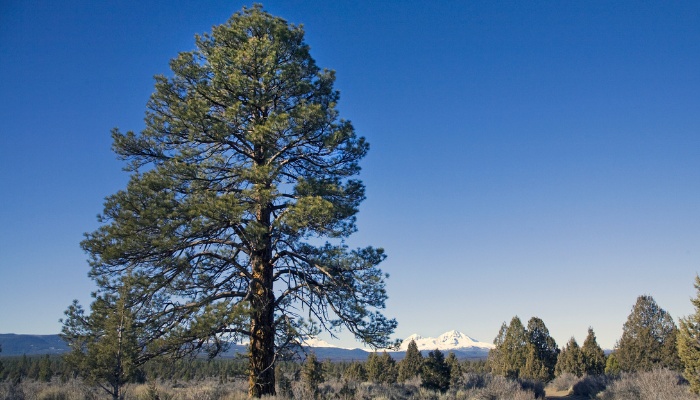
<box><xmin>615</xmin><ymin>295</ymin><xmax>680</xmax><ymax>372</ymax></box>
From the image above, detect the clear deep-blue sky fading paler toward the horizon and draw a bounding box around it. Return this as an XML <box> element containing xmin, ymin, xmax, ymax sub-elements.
<box><xmin>0</xmin><ymin>0</ymin><xmax>700</xmax><ymax>348</ymax></box>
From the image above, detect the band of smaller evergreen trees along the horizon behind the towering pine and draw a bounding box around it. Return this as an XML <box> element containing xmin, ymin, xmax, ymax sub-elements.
<box><xmin>0</xmin><ymin>277</ymin><xmax>700</xmax><ymax>396</ymax></box>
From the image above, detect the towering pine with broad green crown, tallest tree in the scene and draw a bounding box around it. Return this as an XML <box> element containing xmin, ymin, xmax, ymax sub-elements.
<box><xmin>75</xmin><ymin>6</ymin><xmax>396</xmax><ymax>397</ymax></box>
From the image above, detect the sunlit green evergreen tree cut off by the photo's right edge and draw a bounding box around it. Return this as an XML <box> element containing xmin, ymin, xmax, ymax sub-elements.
<box><xmin>677</xmin><ymin>275</ymin><xmax>700</xmax><ymax>393</ymax></box>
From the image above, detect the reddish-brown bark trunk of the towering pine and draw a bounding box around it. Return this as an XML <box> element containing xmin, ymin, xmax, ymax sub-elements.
<box><xmin>248</xmin><ymin>205</ymin><xmax>276</xmax><ymax>397</ymax></box>
